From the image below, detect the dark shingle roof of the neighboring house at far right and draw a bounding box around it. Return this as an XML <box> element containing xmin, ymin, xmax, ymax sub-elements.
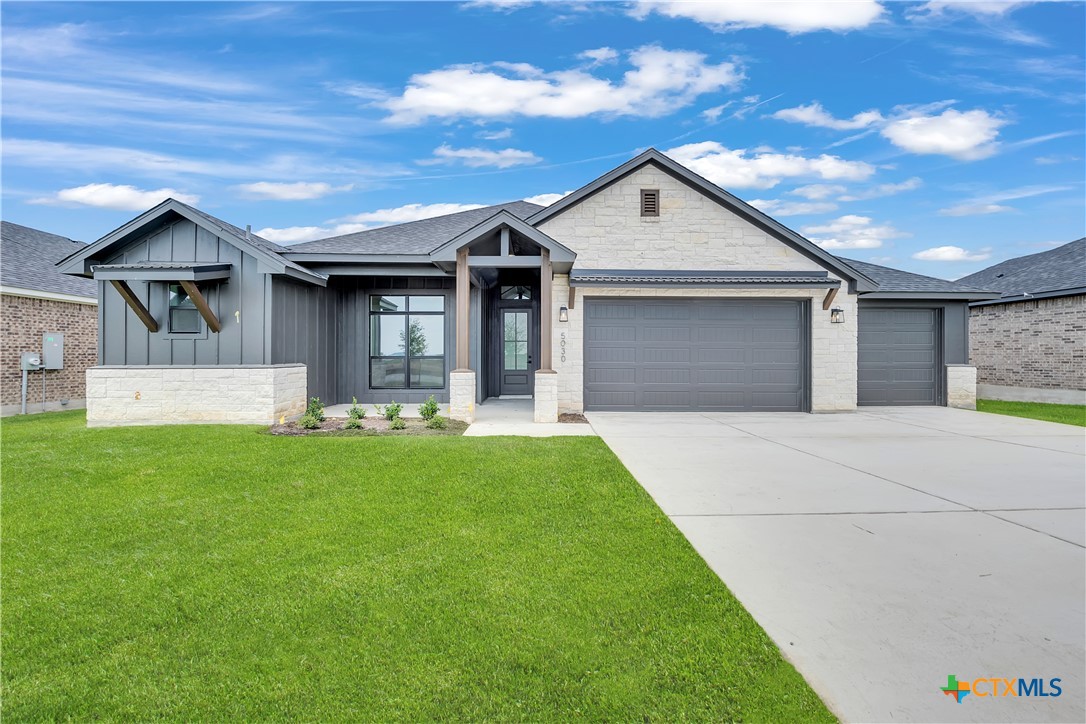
<box><xmin>959</xmin><ymin>238</ymin><xmax>1086</xmax><ymax>296</ymax></box>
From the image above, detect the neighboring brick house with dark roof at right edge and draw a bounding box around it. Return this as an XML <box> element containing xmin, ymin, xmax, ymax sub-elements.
<box><xmin>959</xmin><ymin>239</ymin><xmax>1086</xmax><ymax>405</ymax></box>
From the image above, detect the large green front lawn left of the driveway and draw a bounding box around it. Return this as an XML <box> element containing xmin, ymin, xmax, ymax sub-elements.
<box><xmin>0</xmin><ymin>411</ymin><xmax>832</xmax><ymax>722</ymax></box>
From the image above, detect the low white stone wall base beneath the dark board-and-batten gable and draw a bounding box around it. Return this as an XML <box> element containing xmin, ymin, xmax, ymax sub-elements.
<box><xmin>87</xmin><ymin>365</ymin><xmax>306</xmax><ymax>428</ymax></box>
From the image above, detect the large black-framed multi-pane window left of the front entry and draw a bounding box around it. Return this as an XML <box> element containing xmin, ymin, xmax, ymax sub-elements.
<box><xmin>369</xmin><ymin>294</ymin><xmax>445</xmax><ymax>390</ymax></box>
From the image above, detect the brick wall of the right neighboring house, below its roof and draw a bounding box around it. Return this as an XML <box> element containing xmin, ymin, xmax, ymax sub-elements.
<box><xmin>969</xmin><ymin>294</ymin><xmax>1086</xmax><ymax>390</ymax></box>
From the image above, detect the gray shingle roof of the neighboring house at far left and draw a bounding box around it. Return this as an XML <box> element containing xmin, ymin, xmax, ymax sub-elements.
<box><xmin>0</xmin><ymin>221</ymin><xmax>98</xmax><ymax>299</ymax></box>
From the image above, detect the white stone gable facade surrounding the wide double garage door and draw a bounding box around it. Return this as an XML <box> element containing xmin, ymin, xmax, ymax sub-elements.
<box><xmin>540</xmin><ymin>165</ymin><xmax>858</xmax><ymax>412</ymax></box>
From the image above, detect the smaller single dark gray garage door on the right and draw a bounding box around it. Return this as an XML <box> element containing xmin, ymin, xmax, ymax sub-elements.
<box><xmin>858</xmin><ymin>307</ymin><xmax>939</xmax><ymax>405</ymax></box>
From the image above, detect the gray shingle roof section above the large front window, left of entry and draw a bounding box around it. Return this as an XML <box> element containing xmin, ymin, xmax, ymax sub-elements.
<box><xmin>283</xmin><ymin>201</ymin><xmax>543</xmax><ymax>254</ymax></box>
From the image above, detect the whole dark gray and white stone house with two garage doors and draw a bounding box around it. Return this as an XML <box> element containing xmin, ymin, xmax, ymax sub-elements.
<box><xmin>60</xmin><ymin>150</ymin><xmax>993</xmax><ymax>424</ymax></box>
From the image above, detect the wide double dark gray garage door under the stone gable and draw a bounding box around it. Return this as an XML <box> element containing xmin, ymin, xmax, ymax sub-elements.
<box><xmin>584</xmin><ymin>299</ymin><xmax>807</xmax><ymax>411</ymax></box>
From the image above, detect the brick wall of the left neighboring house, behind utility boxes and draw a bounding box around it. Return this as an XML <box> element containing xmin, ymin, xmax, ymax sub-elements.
<box><xmin>0</xmin><ymin>294</ymin><xmax>98</xmax><ymax>414</ymax></box>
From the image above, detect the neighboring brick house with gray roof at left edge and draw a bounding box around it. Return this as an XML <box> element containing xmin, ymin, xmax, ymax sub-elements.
<box><xmin>0</xmin><ymin>221</ymin><xmax>98</xmax><ymax>415</ymax></box>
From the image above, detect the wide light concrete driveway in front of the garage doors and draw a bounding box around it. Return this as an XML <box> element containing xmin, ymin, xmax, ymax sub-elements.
<box><xmin>589</xmin><ymin>407</ymin><xmax>1086</xmax><ymax>722</ymax></box>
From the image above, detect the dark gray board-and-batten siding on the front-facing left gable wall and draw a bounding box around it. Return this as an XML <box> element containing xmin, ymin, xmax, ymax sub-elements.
<box><xmin>98</xmin><ymin>219</ymin><xmax>273</xmax><ymax>367</ymax></box>
